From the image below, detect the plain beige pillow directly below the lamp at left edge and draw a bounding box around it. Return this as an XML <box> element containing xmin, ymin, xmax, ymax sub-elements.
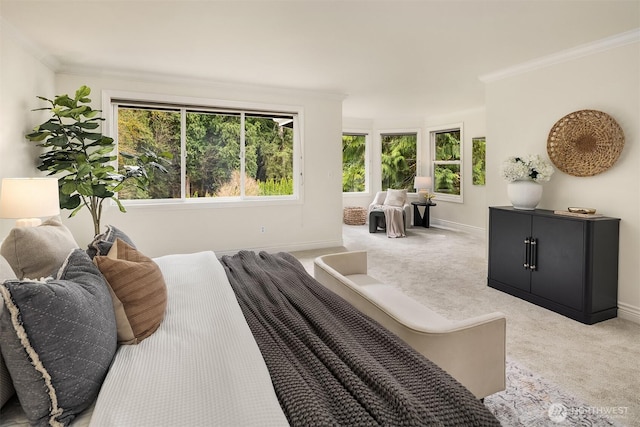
<box><xmin>0</xmin><ymin>217</ymin><xmax>78</xmax><ymax>279</ymax></box>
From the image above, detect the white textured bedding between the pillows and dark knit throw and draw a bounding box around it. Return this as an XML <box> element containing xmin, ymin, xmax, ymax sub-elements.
<box><xmin>0</xmin><ymin>252</ymin><xmax>288</xmax><ymax>427</ymax></box>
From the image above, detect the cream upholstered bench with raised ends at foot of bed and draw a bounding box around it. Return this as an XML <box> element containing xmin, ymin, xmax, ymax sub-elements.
<box><xmin>314</xmin><ymin>251</ymin><xmax>506</xmax><ymax>399</ymax></box>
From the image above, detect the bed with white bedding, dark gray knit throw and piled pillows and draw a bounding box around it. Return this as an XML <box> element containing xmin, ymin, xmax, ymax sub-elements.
<box><xmin>0</xmin><ymin>219</ymin><xmax>499</xmax><ymax>426</ymax></box>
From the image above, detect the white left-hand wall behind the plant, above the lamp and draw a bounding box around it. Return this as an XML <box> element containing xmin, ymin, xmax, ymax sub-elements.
<box><xmin>0</xmin><ymin>18</ymin><xmax>55</xmax><ymax>240</ymax></box>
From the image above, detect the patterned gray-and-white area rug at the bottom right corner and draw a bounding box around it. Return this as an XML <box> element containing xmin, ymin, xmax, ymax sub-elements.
<box><xmin>484</xmin><ymin>360</ymin><xmax>625</xmax><ymax>427</ymax></box>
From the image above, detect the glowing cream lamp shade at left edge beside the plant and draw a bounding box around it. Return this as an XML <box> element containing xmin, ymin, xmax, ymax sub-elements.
<box><xmin>0</xmin><ymin>178</ymin><xmax>60</xmax><ymax>226</ymax></box>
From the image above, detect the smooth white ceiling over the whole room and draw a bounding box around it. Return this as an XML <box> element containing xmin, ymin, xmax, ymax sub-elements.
<box><xmin>0</xmin><ymin>0</ymin><xmax>640</xmax><ymax>118</ymax></box>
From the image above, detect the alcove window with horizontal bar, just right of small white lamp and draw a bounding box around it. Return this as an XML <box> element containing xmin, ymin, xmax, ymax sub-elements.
<box><xmin>430</xmin><ymin>125</ymin><xmax>462</xmax><ymax>201</ymax></box>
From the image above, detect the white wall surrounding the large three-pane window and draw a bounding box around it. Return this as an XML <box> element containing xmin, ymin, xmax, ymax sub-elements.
<box><xmin>56</xmin><ymin>74</ymin><xmax>342</xmax><ymax>256</ymax></box>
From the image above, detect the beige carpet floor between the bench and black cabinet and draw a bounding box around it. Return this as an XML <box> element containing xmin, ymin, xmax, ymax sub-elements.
<box><xmin>294</xmin><ymin>225</ymin><xmax>640</xmax><ymax>426</ymax></box>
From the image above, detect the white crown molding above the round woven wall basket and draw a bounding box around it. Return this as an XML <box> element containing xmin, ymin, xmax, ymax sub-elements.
<box><xmin>478</xmin><ymin>28</ymin><xmax>640</xmax><ymax>83</ymax></box>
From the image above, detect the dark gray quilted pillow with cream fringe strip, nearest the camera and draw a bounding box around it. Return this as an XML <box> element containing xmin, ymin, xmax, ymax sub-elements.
<box><xmin>0</xmin><ymin>249</ymin><xmax>117</xmax><ymax>425</ymax></box>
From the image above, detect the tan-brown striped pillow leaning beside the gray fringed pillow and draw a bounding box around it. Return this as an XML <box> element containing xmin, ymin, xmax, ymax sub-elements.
<box><xmin>93</xmin><ymin>239</ymin><xmax>167</xmax><ymax>344</ymax></box>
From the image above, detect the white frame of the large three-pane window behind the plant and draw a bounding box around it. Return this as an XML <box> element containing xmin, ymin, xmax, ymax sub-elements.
<box><xmin>102</xmin><ymin>90</ymin><xmax>304</xmax><ymax>209</ymax></box>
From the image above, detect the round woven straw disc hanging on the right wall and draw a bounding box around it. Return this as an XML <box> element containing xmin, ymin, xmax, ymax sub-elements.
<box><xmin>547</xmin><ymin>110</ymin><xmax>624</xmax><ymax>176</ymax></box>
